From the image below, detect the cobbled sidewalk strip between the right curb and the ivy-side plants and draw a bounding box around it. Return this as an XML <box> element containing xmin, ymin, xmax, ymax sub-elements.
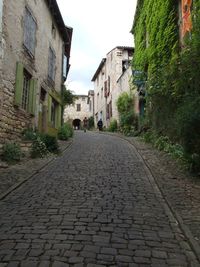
<box><xmin>125</xmin><ymin>138</ymin><xmax>200</xmax><ymax>251</ymax></box>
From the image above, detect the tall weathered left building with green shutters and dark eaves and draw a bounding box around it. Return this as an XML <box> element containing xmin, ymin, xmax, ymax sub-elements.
<box><xmin>0</xmin><ymin>0</ymin><xmax>73</xmax><ymax>147</ymax></box>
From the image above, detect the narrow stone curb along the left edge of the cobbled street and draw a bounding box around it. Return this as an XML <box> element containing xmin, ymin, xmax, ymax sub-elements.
<box><xmin>0</xmin><ymin>139</ymin><xmax>73</xmax><ymax>201</ymax></box>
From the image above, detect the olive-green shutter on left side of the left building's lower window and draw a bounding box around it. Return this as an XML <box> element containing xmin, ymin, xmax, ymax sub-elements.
<box><xmin>14</xmin><ymin>62</ymin><xmax>24</xmax><ymax>106</ymax></box>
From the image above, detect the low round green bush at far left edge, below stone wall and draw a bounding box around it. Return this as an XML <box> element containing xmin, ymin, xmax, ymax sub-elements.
<box><xmin>2</xmin><ymin>143</ymin><xmax>22</xmax><ymax>163</ymax></box>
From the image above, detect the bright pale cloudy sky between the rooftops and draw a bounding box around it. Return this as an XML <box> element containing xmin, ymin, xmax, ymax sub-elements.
<box><xmin>57</xmin><ymin>0</ymin><xmax>137</xmax><ymax>95</ymax></box>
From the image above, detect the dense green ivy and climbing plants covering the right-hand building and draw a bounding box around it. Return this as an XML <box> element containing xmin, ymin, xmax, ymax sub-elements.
<box><xmin>132</xmin><ymin>0</ymin><xmax>200</xmax><ymax>172</ymax></box>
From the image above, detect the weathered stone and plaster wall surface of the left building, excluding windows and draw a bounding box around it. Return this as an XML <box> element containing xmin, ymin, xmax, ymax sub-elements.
<box><xmin>0</xmin><ymin>0</ymin><xmax>63</xmax><ymax>143</ymax></box>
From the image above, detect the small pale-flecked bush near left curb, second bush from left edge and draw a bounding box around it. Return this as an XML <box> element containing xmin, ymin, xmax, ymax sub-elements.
<box><xmin>31</xmin><ymin>136</ymin><xmax>48</xmax><ymax>158</ymax></box>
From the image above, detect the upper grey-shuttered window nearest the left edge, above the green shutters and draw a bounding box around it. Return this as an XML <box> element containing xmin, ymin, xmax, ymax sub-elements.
<box><xmin>24</xmin><ymin>8</ymin><xmax>36</xmax><ymax>56</ymax></box>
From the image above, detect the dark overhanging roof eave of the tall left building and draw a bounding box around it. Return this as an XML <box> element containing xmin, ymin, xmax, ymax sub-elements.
<box><xmin>46</xmin><ymin>0</ymin><xmax>73</xmax><ymax>44</ymax></box>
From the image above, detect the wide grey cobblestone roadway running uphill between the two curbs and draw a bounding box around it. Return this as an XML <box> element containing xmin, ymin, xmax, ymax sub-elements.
<box><xmin>0</xmin><ymin>132</ymin><xmax>200</xmax><ymax>267</ymax></box>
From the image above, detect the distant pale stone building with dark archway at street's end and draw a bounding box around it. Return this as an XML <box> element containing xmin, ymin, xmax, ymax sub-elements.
<box><xmin>64</xmin><ymin>90</ymin><xmax>94</xmax><ymax>129</ymax></box>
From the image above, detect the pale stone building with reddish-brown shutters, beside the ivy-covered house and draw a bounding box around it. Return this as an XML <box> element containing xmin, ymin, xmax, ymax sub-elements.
<box><xmin>92</xmin><ymin>46</ymin><xmax>134</xmax><ymax>127</ymax></box>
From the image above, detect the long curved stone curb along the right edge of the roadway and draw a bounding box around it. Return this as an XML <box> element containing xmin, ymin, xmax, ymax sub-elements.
<box><xmin>101</xmin><ymin>132</ymin><xmax>200</xmax><ymax>262</ymax></box>
